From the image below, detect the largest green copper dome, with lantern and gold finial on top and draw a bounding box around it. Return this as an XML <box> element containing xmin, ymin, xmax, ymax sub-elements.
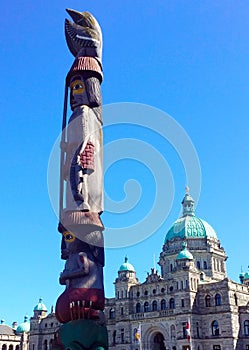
<box><xmin>165</xmin><ymin>193</ymin><xmax>217</xmax><ymax>243</ymax></box>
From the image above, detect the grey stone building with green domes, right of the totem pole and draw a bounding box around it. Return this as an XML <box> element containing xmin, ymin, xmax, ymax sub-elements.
<box><xmin>105</xmin><ymin>191</ymin><xmax>249</xmax><ymax>350</ymax></box>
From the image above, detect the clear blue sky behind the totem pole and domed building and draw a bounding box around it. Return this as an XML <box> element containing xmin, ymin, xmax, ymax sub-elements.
<box><xmin>0</xmin><ymin>0</ymin><xmax>249</xmax><ymax>324</ymax></box>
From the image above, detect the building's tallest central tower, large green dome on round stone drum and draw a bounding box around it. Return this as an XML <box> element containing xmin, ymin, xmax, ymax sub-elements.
<box><xmin>159</xmin><ymin>188</ymin><xmax>227</xmax><ymax>281</ymax></box>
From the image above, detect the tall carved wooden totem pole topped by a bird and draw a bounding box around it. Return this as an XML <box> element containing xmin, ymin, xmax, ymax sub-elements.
<box><xmin>53</xmin><ymin>9</ymin><xmax>108</xmax><ymax>350</ymax></box>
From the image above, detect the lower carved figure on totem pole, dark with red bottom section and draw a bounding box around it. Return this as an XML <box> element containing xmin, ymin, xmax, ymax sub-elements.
<box><xmin>56</xmin><ymin>232</ymin><xmax>104</xmax><ymax>323</ymax></box>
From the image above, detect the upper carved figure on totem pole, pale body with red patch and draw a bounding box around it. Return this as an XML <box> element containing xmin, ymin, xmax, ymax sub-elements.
<box><xmin>64</xmin><ymin>71</ymin><xmax>103</xmax><ymax>214</ymax></box>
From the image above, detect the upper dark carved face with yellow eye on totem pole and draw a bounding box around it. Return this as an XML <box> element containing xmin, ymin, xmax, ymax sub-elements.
<box><xmin>70</xmin><ymin>74</ymin><xmax>89</xmax><ymax>110</ymax></box>
